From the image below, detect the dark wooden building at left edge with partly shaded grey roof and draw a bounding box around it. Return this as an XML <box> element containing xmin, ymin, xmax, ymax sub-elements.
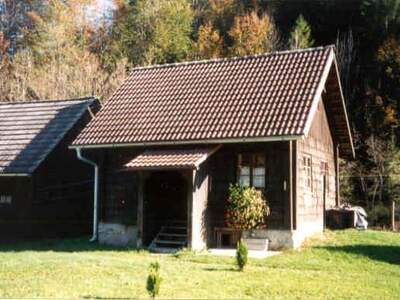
<box><xmin>0</xmin><ymin>98</ymin><xmax>99</xmax><ymax>240</ymax></box>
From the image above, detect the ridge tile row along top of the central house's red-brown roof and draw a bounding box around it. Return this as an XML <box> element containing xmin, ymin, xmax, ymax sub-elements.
<box><xmin>129</xmin><ymin>44</ymin><xmax>335</xmax><ymax>74</ymax></box>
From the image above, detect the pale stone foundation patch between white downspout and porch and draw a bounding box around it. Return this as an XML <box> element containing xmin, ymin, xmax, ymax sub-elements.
<box><xmin>99</xmin><ymin>222</ymin><xmax>137</xmax><ymax>246</ymax></box>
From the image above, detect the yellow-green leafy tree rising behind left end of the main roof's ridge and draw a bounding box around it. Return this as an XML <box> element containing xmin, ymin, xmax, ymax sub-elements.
<box><xmin>114</xmin><ymin>0</ymin><xmax>194</xmax><ymax>65</ymax></box>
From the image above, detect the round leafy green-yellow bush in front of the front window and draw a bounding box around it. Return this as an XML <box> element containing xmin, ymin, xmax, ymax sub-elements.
<box><xmin>225</xmin><ymin>185</ymin><xmax>269</xmax><ymax>230</ymax></box>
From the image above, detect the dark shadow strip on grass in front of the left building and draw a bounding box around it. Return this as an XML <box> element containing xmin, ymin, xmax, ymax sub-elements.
<box><xmin>0</xmin><ymin>237</ymin><xmax>144</xmax><ymax>252</ymax></box>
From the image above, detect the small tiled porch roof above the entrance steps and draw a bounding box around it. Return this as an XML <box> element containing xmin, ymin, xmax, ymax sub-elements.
<box><xmin>124</xmin><ymin>148</ymin><xmax>217</xmax><ymax>170</ymax></box>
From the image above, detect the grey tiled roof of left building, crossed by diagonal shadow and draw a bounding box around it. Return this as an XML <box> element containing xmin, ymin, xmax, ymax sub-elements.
<box><xmin>0</xmin><ymin>98</ymin><xmax>94</xmax><ymax>174</ymax></box>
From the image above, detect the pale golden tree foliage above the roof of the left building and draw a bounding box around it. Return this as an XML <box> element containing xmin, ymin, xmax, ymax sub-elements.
<box><xmin>1</xmin><ymin>0</ymin><xmax>126</xmax><ymax>100</ymax></box>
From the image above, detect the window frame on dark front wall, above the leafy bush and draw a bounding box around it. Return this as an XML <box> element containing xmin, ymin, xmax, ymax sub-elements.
<box><xmin>236</xmin><ymin>151</ymin><xmax>267</xmax><ymax>191</ymax></box>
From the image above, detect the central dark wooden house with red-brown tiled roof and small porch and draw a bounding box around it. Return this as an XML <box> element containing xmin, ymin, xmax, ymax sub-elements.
<box><xmin>72</xmin><ymin>46</ymin><xmax>354</xmax><ymax>249</ymax></box>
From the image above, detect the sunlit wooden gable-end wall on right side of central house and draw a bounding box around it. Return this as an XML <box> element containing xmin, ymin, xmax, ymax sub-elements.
<box><xmin>296</xmin><ymin>100</ymin><xmax>336</xmax><ymax>236</ymax></box>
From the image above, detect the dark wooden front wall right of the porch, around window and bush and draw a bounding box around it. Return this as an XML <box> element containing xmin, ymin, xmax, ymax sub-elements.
<box><xmin>207</xmin><ymin>142</ymin><xmax>290</xmax><ymax>244</ymax></box>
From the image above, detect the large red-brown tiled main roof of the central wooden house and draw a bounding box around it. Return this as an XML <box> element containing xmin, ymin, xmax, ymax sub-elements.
<box><xmin>74</xmin><ymin>46</ymin><xmax>354</xmax><ymax>156</ymax></box>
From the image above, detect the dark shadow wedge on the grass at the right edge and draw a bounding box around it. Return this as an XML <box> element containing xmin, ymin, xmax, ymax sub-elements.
<box><xmin>318</xmin><ymin>244</ymin><xmax>400</xmax><ymax>265</ymax></box>
